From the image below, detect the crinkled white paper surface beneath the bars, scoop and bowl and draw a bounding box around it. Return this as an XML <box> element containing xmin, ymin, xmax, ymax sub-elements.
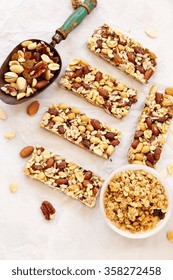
<box><xmin>0</xmin><ymin>0</ymin><xmax>173</xmax><ymax>259</ymax></box>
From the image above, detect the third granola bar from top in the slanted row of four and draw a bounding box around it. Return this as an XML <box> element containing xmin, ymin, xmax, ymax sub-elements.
<box><xmin>40</xmin><ymin>104</ymin><xmax>121</xmax><ymax>159</ymax></box>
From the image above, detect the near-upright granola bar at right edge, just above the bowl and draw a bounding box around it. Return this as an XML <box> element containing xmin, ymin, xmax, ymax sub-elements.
<box><xmin>128</xmin><ymin>86</ymin><xmax>173</xmax><ymax>167</ymax></box>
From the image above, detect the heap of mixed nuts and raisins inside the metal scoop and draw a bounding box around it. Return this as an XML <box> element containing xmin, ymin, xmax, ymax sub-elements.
<box><xmin>1</xmin><ymin>41</ymin><xmax>60</xmax><ymax>100</ymax></box>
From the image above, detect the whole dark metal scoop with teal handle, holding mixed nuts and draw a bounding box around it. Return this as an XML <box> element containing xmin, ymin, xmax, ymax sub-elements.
<box><xmin>0</xmin><ymin>0</ymin><xmax>97</xmax><ymax>105</ymax></box>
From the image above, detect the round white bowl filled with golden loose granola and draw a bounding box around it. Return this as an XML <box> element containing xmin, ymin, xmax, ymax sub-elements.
<box><xmin>101</xmin><ymin>165</ymin><xmax>170</xmax><ymax>238</ymax></box>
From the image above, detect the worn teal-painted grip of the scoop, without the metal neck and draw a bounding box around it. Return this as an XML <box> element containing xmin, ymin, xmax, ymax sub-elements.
<box><xmin>57</xmin><ymin>0</ymin><xmax>97</xmax><ymax>39</ymax></box>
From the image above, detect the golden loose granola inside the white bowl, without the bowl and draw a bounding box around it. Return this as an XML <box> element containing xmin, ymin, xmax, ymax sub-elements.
<box><xmin>104</xmin><ymin>170</ymin><xmax>168</xmax><ymax>234</ymax></box>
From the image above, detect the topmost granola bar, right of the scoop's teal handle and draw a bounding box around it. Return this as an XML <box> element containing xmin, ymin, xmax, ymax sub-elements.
<box><xmin>88</xmin><ymin>24</ymin><xmax>157</xmax><ymax>84</ymax></box>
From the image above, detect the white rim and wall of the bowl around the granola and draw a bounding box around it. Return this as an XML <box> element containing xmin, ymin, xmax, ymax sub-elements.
<box><xmin>100</xmin><ymin>164</ymin><xmax>172</xmax><ymax>239</ymax></box>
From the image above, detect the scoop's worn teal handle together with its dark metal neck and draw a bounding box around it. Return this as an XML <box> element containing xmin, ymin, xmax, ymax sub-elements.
<box><xmin>51</xmin><ymin>0</ymin><xmax>97</xmax><ymax>46</ymax></box>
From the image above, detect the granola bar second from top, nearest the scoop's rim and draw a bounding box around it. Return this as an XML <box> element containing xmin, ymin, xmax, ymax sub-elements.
<box><xmin>60</xmin><ymin>58</ymin><xmax>138</xmax><ymax>119</ymax></box>
